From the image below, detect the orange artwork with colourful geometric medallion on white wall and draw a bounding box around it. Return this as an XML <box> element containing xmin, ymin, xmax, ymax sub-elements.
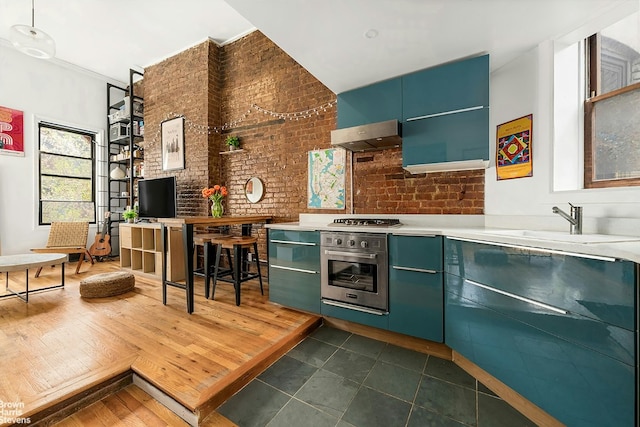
<box><xmin>496</xmin><ymin>114</ymin><xmax>533</xmax><ymax>181</ymax></box>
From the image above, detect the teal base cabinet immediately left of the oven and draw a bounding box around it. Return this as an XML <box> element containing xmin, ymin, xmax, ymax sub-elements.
<box><xmin>269</xmin><ymin>229</ymin><xmax>320</xmax><ymax>313</ymax></box>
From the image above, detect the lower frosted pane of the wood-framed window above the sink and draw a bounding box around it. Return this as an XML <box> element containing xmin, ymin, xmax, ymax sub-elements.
<box><xmin>593</xmin><ymin>90</ymin><xmax>640</xmax><ymax>181</ymax></box>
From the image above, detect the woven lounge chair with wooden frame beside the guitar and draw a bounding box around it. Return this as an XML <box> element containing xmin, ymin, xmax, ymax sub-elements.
<box><xmin>31</xmin><ymin>221</ymin><xmax>93</xmax><ymax>277</ymax></box>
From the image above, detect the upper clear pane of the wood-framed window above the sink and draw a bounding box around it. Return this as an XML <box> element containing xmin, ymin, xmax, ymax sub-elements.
<box><xmin>600</xmin><ymin>13</ymin><xmax>640</xmax><ymax>94</ymax></box>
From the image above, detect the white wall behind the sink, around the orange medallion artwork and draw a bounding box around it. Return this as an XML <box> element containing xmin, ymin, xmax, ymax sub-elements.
<box><xmin>485</xmin><ymin>4</ymin><xmax>640</xmax><ymax>235</ymax></box>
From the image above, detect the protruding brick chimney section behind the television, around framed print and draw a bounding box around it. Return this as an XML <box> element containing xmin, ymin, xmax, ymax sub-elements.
<box><xmin>144</xmin><ymin>42</ymin><xmax>220</xmax><ymax>215</ymax></box>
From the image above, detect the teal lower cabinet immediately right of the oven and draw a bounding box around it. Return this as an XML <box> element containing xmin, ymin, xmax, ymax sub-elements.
<box><xmin>389</xmin><ymin>235</ymin><xmax>444</xmax><ymax>342</ymax></box>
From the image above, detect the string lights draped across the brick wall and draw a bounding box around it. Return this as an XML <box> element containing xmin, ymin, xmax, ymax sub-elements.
<box><xmin>145</xmin><ymin>101</ymin><xmax>337</xmax><ymax>145</ymax></box>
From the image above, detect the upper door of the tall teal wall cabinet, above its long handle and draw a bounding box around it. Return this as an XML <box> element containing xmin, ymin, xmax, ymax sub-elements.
<box><xmin>402</xmin><ymin>55</ymin><xmax>489</xmax><ymax>121</ymax></box>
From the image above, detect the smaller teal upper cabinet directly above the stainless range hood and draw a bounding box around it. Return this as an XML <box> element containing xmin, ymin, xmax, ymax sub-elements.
<box><xmin>338</xmin><ymin>78</ymin><xmax>402</xmax><ymax>129</ymax></box>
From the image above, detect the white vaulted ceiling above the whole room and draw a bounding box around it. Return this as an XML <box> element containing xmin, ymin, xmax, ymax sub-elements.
<box><xmin>0</xmin><ymin>0</ymin><xmax>639</xmax><ymax>93</ymax></box>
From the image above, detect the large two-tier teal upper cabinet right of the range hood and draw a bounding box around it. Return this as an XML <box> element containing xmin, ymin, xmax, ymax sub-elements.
<box><xmin>402</xmin><ymin>55</ymin><xmax>489</xmax><ymax>173</ymax></box>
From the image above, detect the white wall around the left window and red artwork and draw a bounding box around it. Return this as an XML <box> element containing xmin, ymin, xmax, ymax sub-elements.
<box><xmin>0</xmin><ymin>41</ymin><xmax>114</xmax><ymax>255</ymax></box>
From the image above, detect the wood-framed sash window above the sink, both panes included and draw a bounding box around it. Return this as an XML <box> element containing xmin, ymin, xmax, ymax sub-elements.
<box><xmin>585</xmin><ymin>13</ymin><xmax>640</xmax><ymax>187</ymax></box>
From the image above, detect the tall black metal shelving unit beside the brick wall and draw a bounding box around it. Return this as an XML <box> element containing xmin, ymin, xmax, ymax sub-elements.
<box><xmin>107</xmin><ymin>70</ymin><xmax>144</xmax><ymax>256</ymax></box>
